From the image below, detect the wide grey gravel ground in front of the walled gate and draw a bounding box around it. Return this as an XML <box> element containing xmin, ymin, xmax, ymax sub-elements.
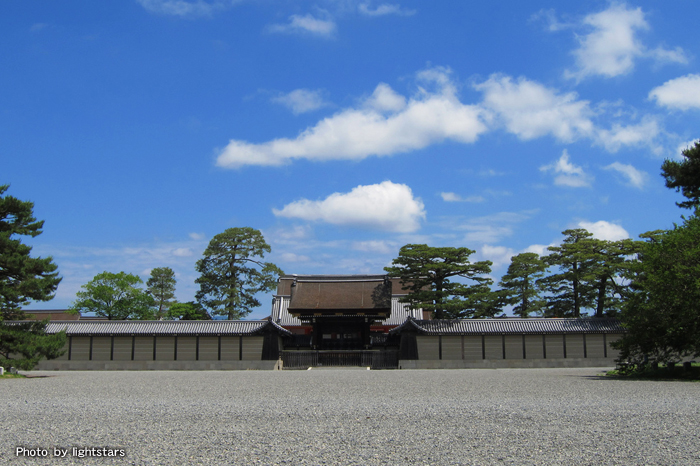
<box><xmin>0</xmin><ymin>369</ymin><xmax>700</xmax><ymax>465</ymax></box>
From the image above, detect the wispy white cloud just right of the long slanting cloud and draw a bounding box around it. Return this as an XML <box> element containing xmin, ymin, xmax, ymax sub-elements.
<box><xmin>474</xmin><ymin>74</ymin><xmax>594</xmax><ymax>142</ymax></box>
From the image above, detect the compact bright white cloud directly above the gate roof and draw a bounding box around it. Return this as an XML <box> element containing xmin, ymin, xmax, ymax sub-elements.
<box><xmin>273</xmin><ymin>181</ymin><xmax>425</xmax><ymax>233</ymax></box>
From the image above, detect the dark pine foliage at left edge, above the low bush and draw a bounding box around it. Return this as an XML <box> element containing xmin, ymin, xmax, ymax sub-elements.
<box><xmin>0</xmin><ymin>185</ymin><xmax>61</xmax><ymax>320</ymax></box>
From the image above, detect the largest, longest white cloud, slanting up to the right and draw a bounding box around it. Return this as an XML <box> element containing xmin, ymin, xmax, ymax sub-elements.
<box><xmin>217</xmin><ymin>68</ymin><xmax>487</xmax><ymax>168</ymax></box>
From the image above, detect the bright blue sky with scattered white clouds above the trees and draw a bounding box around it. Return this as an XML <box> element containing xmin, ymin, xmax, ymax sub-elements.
<box><xmin>5</xmin><ymin>0</ymin><xmax>700</xmax><ymax>318</ymax></box>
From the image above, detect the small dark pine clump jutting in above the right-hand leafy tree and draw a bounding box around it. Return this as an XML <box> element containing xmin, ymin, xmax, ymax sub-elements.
<box><xmin>661</xmin><ymin>142</ymin><xmax>700</xmax><ymax>209</ymax></box>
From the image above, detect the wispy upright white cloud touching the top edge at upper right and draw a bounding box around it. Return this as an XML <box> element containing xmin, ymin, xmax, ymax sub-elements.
<box><xmin>566</xmin><ymin>4</ymin><xmax>688</xmax><ymax>81</ymax></box>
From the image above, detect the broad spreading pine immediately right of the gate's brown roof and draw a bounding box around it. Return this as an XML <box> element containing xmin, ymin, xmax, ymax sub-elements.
<box><xmin>384</xmin><ymin>244</ymin><xmax>500</xmax><ymax>319</ymax></box>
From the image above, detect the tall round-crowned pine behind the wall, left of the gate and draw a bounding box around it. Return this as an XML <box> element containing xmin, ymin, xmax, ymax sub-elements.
<box><xmin>195</xmin><ymin>227</ymin><xmax>284</xmax><ymax>319</ymax></box>
